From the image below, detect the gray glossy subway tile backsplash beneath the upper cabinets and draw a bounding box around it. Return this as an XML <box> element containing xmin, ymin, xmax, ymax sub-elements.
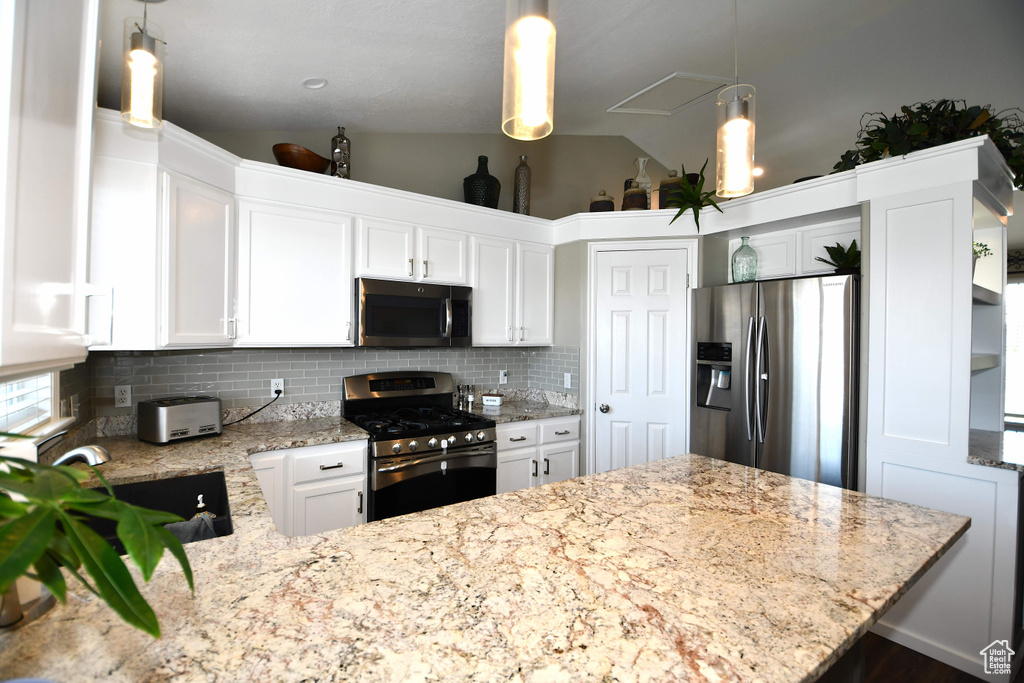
<box><xmin>71</xmin><ymin>346</ymin><xmax>580</xmax><ymax>419</ymax></box>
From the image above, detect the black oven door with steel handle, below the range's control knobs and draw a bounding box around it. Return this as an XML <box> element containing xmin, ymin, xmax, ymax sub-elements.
<box><xmin>367</xmin><ymin>442</ymin><xmax>498</xmax><ymax>521</ymax></box>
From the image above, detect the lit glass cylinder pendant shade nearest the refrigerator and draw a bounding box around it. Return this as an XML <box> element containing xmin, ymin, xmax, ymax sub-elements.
<box><xmin>715</xmin><ymin>85</ymin><xmax>755</xmax><ymax>197</ymax></box>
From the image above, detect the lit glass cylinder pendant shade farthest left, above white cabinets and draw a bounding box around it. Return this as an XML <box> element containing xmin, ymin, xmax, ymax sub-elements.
<box><xmin>121</xmin><ymin>16</ymin><xmax>164</xmax><ymax>128</ymax></box>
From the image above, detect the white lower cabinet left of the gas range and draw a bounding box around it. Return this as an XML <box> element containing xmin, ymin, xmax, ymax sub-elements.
<box><xmin>250</xmin><ymin>441</ymin><xmax>367</xmax><ymax>536</ymax></box>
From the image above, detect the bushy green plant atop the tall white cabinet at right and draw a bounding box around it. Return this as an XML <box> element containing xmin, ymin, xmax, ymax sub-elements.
<box><xmin>833</xmin><ymin>99</ymin><xmax>1024</xmax><ymax>189</ymax></box>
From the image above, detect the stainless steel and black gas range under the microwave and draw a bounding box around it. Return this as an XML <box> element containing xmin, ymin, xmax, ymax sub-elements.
<box><xmin>341</xmin><ymin>371</ymin><xmax>498</xmax><ymax>521</ymax></box>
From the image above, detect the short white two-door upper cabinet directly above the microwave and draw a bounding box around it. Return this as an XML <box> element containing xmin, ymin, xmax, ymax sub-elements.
<box><xmin>355</xmin><ymin>216</ymin><xmax>469</xmax><ymax>285</ymax></box>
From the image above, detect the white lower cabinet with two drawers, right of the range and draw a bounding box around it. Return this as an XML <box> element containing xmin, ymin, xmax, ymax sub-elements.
<box><xmin>497</xmin><ymin>416</ymin><xmax>580</xmax><ymax>494</ymax></box>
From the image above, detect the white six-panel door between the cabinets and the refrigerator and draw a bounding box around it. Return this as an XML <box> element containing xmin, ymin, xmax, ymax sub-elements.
<box><xmin>594</xmin><ymin>249</ymin><xmax>689</xmax><ymax>472</ymax></box>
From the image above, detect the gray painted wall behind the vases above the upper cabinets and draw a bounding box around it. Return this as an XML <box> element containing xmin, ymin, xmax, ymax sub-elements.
<box><xmin>191</xmin><ymin>129</ymin><xmax>671</xmax><ymax>219</ymax></box>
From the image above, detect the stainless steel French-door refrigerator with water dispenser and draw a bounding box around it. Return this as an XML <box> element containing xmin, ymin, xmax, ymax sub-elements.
<box><xmin>690</xmin><ymin>275</ymin><xmax>860</xmax><ymax>488</ymax></box>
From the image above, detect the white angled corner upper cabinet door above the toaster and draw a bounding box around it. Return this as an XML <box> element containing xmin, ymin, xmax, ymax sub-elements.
<box><xmin>161</xmin><ymin>172</ymin><xmax>234</xmax><ymax>346</ymax></box>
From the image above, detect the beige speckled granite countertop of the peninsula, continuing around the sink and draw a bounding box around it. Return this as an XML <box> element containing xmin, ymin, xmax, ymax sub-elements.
<box><xmin>0</xmin><ymin>418</ymin><xmax>970</xmax><ymax>682</ymax></box>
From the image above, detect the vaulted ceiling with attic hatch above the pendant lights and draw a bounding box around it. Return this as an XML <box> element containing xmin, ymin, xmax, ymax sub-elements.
<box><xmin>99</xmin><ymin>0</ymin><xmax>1024</xmax><ymax>242</ymax></box>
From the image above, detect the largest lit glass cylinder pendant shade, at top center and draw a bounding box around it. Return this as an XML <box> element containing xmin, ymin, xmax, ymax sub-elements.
<box><xmin>502</xmin><ymin>0</ymin><xmax>555</xmax><ymax>140</ymax></box>
